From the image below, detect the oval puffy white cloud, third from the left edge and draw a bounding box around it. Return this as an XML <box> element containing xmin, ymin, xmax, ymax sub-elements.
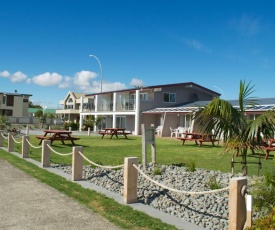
<box><xmin>32</xmin><ymin>72</ymin><xmax>62</xmax><ymax>86</ymax></box>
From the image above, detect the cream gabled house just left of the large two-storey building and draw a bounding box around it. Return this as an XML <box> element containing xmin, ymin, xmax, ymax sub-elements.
<box><xmin>56</xmin><ymin>92</ymin><xmax>92</xmax><ymax>122</ymax></box>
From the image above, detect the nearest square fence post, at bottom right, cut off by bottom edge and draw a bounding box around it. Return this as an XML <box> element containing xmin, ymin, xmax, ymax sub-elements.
<box><xmin>228</xmin><ymin>177</ymin><xmax>247</xmax><ymax>230</ymax></box>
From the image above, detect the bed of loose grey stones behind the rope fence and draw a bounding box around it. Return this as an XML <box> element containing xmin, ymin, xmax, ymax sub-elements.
<box><xmin>52</xmin><ymin>164</ymin><xmax>258</xmax><ymax>230</ymax></box>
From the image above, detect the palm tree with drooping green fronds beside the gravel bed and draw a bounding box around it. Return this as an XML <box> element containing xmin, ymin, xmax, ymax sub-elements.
<box><xmin>193</xmin><ymin>81</ymin><xmax>275</xmax><ymax>175</ymax></box>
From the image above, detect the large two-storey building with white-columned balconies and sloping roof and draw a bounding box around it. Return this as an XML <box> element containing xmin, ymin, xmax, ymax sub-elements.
<box><xmin>78</xmin><ymin>82</ymin><xmax>220</xmax><ymax>136</ymax></box>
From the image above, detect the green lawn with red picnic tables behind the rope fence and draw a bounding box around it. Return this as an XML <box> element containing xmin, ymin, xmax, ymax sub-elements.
<box><xmin>4</xmin><ymin>136</ymin><xmax>274</xmax><ymax>175</ymax></box>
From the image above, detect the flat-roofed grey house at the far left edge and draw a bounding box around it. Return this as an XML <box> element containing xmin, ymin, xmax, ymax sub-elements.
<box><xmin>0</xmin><ymin>90</ymin><xmax>32</xmax><ymax>118</ymax></box>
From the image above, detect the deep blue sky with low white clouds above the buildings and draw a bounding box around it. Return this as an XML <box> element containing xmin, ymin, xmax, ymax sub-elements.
<box><xmin>0</xmin><ymin>0</ymin><xmax>275</xmax><ymax>107</ymax></box>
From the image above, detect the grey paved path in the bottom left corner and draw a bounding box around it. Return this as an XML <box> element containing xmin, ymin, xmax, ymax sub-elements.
<box><xmin>0</xmin><ymin>159</ymin><xmax>119</xmax><ymax>230</ymax></box>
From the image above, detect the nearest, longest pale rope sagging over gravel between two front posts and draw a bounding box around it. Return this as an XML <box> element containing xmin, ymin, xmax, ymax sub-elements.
<box><xmin>133</xmin><ymin>164</ymin><xmax>229</xmax><ymax>195</ymax></box>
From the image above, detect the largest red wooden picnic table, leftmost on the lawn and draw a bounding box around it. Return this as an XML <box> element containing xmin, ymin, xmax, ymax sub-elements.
<box><xmin>36</xmin><ymin>130</ymin><xmax>80</xmax><ymax>145</ymax></box>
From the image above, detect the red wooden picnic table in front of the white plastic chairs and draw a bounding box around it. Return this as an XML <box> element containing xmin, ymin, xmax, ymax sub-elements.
<box><xmin>178</xmin><ymin>132</ymin><xmax>218</xmax><ymax>147</ymax></box>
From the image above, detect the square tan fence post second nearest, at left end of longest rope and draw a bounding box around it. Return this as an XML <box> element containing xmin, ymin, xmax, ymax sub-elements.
<box><xmin>123</xmin><ymin>157</ymin><xmax>138</xmax><ymax>204</ymax></box>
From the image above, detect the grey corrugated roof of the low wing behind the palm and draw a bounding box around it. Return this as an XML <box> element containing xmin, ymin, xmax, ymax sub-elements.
<box><xmin>143</xmin><ymin>98</ymin><xmax>275</xmax><ymax>113</ymax></box>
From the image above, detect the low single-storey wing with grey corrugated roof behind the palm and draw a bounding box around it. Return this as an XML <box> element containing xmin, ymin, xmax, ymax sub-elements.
<box><xmin>146</xmin><ymin>98</ymin><xmax>275</xmax><ymax>136</ymax></box>
